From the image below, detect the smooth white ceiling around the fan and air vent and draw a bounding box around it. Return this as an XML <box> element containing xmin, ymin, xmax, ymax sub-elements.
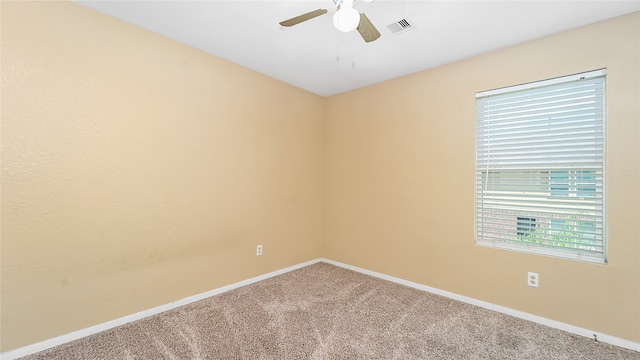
<box><xmin>76</xmin><ymin>0</ymin><xmax>640</xmax><ymax>96</ymax></box>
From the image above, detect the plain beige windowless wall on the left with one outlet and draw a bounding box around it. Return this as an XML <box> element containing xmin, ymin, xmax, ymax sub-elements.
<box><xmin>1</xmin><ymin>1</ymin><xmax>325</xmax><ymax>351</ymax></box>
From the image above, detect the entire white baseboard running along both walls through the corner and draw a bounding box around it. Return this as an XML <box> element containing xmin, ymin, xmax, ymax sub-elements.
<box><xmin>0</xmin><ymin>258</ymin><xmax>640</xmax><ymax>360</ymax></box>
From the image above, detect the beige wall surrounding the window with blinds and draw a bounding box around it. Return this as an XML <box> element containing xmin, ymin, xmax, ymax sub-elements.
<box><xmin>323</xmin><ymin>13</ymin><xmax>640</xmax><ymax>342</ymax></box>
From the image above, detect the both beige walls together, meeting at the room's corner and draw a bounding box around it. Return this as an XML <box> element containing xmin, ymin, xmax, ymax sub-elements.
<box><xmin>0</xmin><ymin>2</ymin><xmax>640</xmax><ymax>351</ymax></box>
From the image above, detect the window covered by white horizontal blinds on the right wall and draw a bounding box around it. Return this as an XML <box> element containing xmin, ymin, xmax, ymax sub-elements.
<box><xmin>475</xmin><ymin>70</ymin><xmax>606</xmax><ymax>263</ymax></box>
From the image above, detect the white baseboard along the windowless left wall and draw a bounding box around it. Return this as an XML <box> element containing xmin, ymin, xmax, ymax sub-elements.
<box><xmin>0</xmin><ymin>259</ymin><xmax>321</xmax><ymax>360</ymax></box>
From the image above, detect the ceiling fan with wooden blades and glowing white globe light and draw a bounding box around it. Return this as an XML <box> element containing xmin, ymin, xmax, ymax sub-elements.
<box><xmin>280</xmin><ymin>0</ymin><xmax>380</xmax><ymax>42</ymax></box>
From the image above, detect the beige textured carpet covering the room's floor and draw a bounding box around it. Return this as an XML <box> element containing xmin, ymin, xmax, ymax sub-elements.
<box><xmin>17</xmin><ymin>263</ymin><xmax>640</xmax><ymax>360</ymax></box>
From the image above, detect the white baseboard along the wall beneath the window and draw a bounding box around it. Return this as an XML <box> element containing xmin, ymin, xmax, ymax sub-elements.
<box><xmin>321</xmin><ymin>259</ymin><xmax>640</xmax><ymax>352</ymax></box>
